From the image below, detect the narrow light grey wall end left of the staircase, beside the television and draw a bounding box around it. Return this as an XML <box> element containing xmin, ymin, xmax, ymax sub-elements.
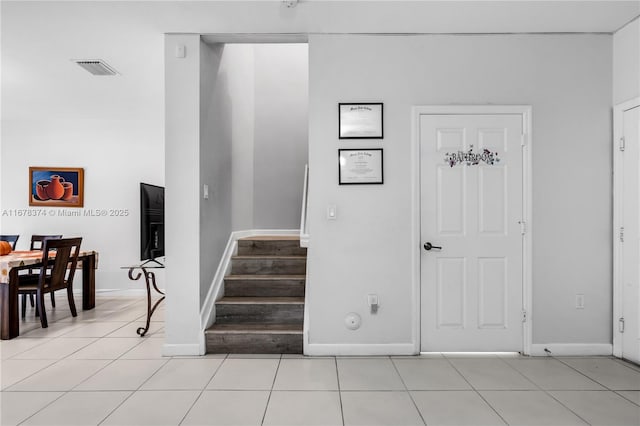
<box><xmin>163</xmin><ymin>35</ymin><xmax>202</xmax><ymax>355</ymax></box>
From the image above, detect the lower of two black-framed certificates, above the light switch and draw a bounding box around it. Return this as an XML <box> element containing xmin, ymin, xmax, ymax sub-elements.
<box><xmin>338</xmin><ymin>148</ymin><xmax>384</xmax><ymax>185</ymax></box>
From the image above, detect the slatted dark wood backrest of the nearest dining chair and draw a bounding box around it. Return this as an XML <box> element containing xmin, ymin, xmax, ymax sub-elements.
<box><xmin>38</xmin><ymin>238</ymin><xmax>82</xmax><ymax>290</ymax></box>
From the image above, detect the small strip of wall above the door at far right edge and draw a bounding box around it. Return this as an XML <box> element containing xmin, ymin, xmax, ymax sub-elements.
<box><xmin>613</xmin><ymin>18</ymin><xmax>640</xmax><ymax>105</ymax></box>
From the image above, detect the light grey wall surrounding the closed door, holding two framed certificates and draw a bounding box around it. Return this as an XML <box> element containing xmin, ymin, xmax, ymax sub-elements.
<box><xmin>307</xmin><ymin>35</ymin><xmax>612</xmax><ymax>352</ymax></box>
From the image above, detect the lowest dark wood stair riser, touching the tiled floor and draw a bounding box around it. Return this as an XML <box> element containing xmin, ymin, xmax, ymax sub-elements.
<box><xmin>206</xmin><ymin>333</ymin><xmax>302</xmax><ymax>354</ymax></box>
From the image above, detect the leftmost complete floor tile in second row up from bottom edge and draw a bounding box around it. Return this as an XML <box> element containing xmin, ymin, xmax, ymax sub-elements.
<box><xmin>9</xmin><ymin>359</ymin><xmax>110</xmax><ymax>391</ymax></box>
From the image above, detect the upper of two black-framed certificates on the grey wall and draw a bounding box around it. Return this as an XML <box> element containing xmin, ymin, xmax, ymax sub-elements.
<box><xmin>338</xmin><ymin>103</ymin><xmax>383</xmax><ymax>139</ymax></box>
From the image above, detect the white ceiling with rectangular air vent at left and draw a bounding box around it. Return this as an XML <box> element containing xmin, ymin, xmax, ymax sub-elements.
<box><xmin>0</xmin><ymin>0</ymin><xmax>640</xmax><ymax>122</ymax></box>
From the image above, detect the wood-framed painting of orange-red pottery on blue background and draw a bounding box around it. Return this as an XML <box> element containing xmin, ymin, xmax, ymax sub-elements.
<box><xmin>29</xmin><ymin>167</ymin><xmax>84</xmax><ymax>207</ymax></box>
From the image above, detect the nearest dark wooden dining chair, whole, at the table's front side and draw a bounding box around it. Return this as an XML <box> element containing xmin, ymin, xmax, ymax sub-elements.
<box><xmin>18</xmin><ymin>238</ymin><xmax>82</xmax><ymax>328</ymax></box>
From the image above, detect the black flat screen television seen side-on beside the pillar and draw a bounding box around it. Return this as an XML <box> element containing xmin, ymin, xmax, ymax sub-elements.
<box><xmin>140</xmin><ymin>183</ymin><xmax>164</xmax><ymax>265</ymax></box>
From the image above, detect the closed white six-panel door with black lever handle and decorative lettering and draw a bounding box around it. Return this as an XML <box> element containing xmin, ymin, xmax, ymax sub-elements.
<box><xmin>418</xmin><ymin>113</ymin><xmax>524</xmax><ymax>352</ymax></box>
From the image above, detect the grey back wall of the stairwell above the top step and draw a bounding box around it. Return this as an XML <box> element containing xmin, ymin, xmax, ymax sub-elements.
<box><xmin>253</xmin><ymin>44</ymin><xmax>309</xmax><ymax>229</ymax></box>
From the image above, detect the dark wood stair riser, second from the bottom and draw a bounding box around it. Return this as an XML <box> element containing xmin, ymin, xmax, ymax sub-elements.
<box><xmin>216</xmin><ymin>304</ymin><xmax>304</xmax><ymax>324</ymax></box>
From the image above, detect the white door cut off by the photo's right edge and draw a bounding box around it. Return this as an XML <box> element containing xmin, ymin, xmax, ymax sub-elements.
<box><xmin>618</xmin><ymin>102</ymin><xmax>640</xmax><ymax>362</ymax></box>
